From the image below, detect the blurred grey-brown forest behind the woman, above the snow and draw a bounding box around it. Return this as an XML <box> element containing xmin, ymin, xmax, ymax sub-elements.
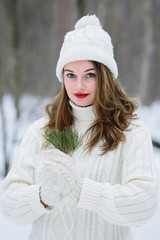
<box><xmin>0</xmin><ymin>0</ymin><xmax>160</xmax><ymax>176</ymax></box>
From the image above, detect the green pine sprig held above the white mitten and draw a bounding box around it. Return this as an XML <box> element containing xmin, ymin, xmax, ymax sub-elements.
<box><xmin>44</xmin><ymin>127</ymin><xmax>82</xmax><ymax>154</ymax></box>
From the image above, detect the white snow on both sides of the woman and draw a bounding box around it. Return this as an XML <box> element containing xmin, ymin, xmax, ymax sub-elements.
<box><xmin>0</xmin><ymin>95</ymin><xmax>160</xmax><ymax>240</ymax></box>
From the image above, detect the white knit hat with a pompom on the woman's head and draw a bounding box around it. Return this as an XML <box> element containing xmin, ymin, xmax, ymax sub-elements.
<box><xmin>56</xmin><ymin>15</ymin><xmax>118</xmax><ymax>82</ymax></box>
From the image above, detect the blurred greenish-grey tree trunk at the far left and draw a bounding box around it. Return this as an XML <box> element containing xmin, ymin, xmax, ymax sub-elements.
<box><xmin>3</xmin><ymin>0</ymin><xmax>21</xmax><ymax>118</ymax></box>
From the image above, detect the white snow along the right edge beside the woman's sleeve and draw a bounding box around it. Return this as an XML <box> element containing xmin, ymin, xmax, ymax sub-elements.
<box><xmin>132</xmin><ymin>101</ymin><xmax>160</xmax><ymax>240</ymax></box>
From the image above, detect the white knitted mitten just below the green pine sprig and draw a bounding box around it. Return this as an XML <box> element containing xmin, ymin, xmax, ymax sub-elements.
<box><xmin>39</xmin><ymin>149</ymin><xmax>76</xmax><ymax>206</ymax></box>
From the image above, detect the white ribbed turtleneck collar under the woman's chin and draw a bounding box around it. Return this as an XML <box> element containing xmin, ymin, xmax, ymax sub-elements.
<box><xmin>69</xmin><ymin>101</ymin><xmax>96</xmax><ymax>121</ymax></box>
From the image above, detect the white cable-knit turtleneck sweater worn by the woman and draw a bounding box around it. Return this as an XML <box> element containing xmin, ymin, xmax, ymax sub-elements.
<box><xmin>0</xmin><ymin>101</ymin><xmax>157</xmax><ymax>240</ymax></box>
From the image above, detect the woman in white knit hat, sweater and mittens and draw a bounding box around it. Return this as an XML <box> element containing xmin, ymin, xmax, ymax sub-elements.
<box><xmin>1</xmin><ymin>15</ymin><xmax>157</xmax><ymax>240</ymax></box>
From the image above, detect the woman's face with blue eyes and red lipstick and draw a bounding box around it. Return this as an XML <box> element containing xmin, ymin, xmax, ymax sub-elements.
<box><xmin>63</xmin><ymin>61</ymin><xmax>97</xmax><ymax>107</ymax></box>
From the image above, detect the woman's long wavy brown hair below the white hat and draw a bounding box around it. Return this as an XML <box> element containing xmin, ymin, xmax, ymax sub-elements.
<box><xmin>45</xmin><ymin>62</ymin><xmax>138</xmax><ymax>154</ymax></box>
